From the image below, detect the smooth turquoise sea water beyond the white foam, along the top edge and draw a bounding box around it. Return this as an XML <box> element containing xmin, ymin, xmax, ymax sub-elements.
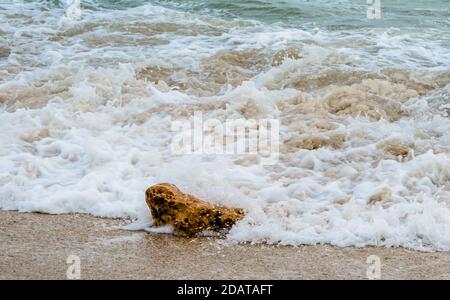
<box><xmin>36</xmin><ymin>0</ymin><xmax>450</xmax><ymax>30</ymax></box>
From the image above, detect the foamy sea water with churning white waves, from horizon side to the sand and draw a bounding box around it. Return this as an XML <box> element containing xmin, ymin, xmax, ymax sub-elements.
<box><xmin>0</xmin><ymin>0</ymin><xmax>450</xmax><ymax>250</ymax></box>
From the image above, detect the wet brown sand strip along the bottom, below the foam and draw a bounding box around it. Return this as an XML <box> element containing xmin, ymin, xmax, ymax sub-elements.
<box><xmin>0</xmin><ymin>211</ymin><xmax>450</xmax><ymax>279</ymax></box>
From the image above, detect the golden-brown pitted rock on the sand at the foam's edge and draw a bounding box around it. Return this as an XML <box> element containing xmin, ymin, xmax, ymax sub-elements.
<box><xmin>145</xmin><ymin>183</ymin><xmax>244</xmax><ymax>236</ymax></box>
